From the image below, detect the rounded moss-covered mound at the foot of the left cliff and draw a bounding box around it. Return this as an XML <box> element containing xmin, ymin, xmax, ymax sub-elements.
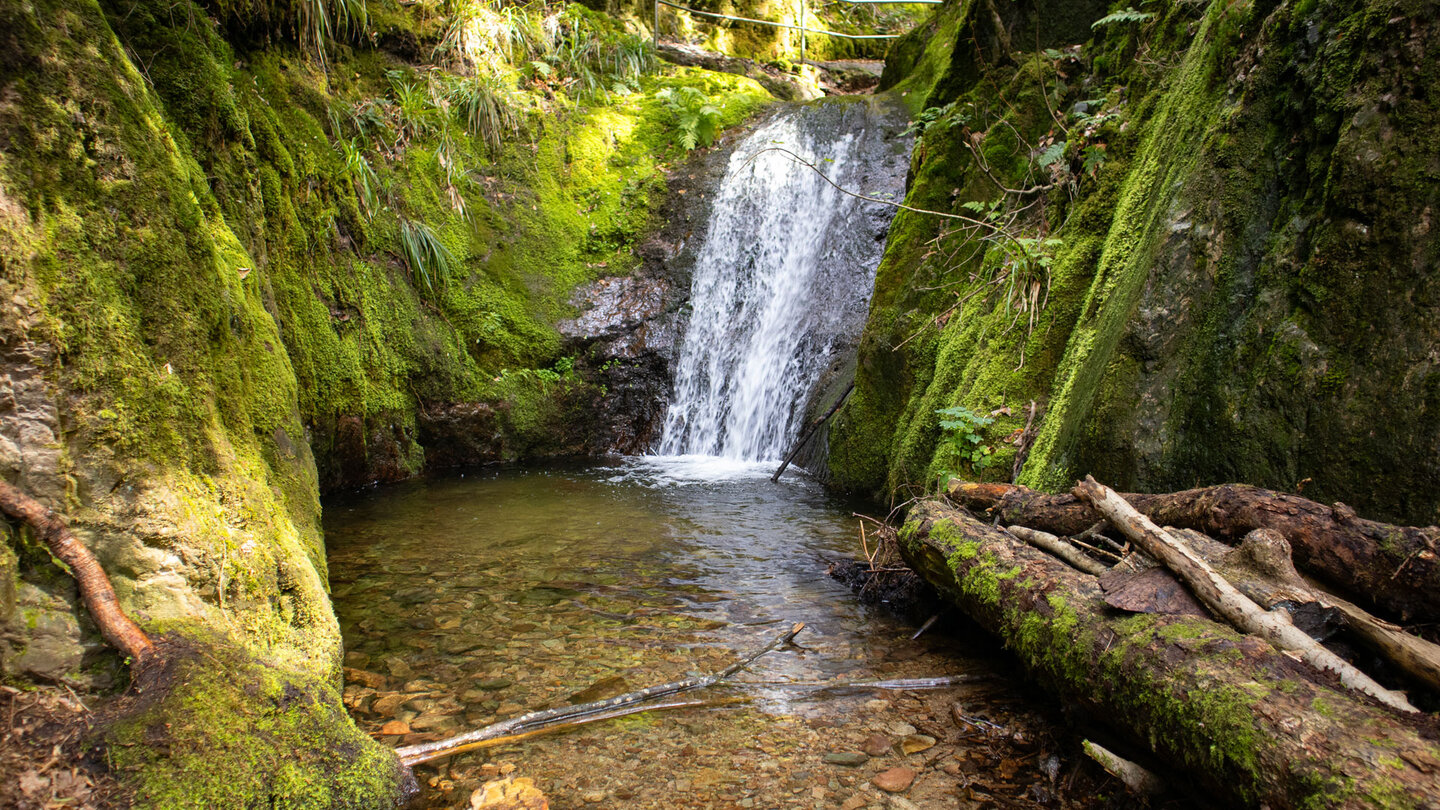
<box><xmin>99</xmin><ymin>636</ymin><xmax>413</xmax><ymax>810</ymax></box>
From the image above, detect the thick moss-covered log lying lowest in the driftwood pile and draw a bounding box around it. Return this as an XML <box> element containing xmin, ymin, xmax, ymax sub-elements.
<box><xmin>901</xmin><ymin>502</ymin><xmax>1440</xmax><ymax>809</ymax></box>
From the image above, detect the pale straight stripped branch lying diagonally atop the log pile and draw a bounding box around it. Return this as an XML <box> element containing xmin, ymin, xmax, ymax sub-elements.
<box><xmin>1074</xmin><ymin>476</ymin><xmax>1418</xmax><ymax>712</ymax></box>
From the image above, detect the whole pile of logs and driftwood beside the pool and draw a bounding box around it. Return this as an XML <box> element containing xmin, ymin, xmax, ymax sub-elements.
<box><xmin>900</xmin><ymin>479</ymin><xmax>1440</xmax><ymax>809</ymax></box>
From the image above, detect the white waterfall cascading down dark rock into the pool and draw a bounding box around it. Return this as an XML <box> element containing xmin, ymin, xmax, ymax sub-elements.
<box><xmin>658</xmin><ymin>99</ymin><xmax>910</xmax><ymax>461</ymax></box>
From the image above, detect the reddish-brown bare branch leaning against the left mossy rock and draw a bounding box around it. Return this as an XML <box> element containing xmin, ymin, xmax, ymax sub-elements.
<box><xmin>0</xmin><ymin>481</ymin><xmax>156</xmax><ymax>664</ymax></box>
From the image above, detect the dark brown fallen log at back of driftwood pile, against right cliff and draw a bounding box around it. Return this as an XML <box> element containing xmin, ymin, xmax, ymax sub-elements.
<box><xmin>949</xmin><ymin>480</ymin><xmax>1440</xmax><ymax>621</ymax></box>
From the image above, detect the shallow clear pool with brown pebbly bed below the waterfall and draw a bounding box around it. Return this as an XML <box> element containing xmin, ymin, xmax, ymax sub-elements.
<box><xmin>325</xmin><ymin>460</ymin><xmax>1157</xmax><ymax>810</ymax></box>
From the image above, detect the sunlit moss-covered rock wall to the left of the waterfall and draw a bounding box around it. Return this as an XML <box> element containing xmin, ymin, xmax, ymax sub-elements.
<box><xmin>0</xmin><ymin>0</ymin><xmax>769</xmax><ymax>807</ymax></box>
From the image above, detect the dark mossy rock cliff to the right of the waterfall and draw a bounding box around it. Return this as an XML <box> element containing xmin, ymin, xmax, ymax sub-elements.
<box><xmin>831</xmin><ymin>0</ymin><xmax>1440</xmax><ymax>523</ymax></box>
